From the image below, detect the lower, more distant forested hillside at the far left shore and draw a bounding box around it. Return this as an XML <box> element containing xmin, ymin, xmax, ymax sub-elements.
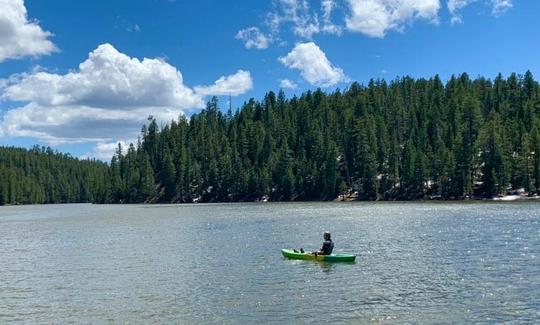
<box><xmin>0</xmin><ymin>146</ymin><xmax>110</xmax><ymax>205</ymax></box>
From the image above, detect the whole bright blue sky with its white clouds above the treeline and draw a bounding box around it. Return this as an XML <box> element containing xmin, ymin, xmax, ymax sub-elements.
<box><xmin>0</xmin><ymin>0</ymin><xmax>540</xmax><ymax>160</ymax></box>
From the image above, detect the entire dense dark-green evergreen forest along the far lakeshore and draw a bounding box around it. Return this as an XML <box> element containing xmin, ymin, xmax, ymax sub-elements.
<box><xmin>0</xmin><ymin>71</ymin><xmax>540</xmax><ymax>204</ymax></box>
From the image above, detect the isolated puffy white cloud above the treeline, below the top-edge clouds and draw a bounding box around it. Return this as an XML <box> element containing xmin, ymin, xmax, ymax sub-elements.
<box><xmin>278</xmin><ymin>42</ymin><xmax>347</xmax><ymax>87</ymax></box>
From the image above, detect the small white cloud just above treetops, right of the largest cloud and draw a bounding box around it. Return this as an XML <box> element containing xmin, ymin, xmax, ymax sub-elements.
<box><xmin>195</xmin><ymin>70</ymin><xmax>253</xmax><ymax>96</ymax></box>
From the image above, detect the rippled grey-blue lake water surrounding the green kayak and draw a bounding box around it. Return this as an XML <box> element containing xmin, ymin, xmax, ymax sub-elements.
<box><xmin>0</xmin><ymin>202</ymin><xmax>540</xmax><ymax>324</ymax></box>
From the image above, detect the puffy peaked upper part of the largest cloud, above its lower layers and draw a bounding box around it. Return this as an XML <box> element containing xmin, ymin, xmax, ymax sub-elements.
<box><xmin>3</xmin><ymin>44</ymin><xmax>202</xmax><ymax>110</ymax></box>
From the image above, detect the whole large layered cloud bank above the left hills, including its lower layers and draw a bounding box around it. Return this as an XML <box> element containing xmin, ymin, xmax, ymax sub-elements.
<box><xmin>0</xmin><ymin>44</ymin><xmax>253</xmax><ymax>145</ymax></box>
